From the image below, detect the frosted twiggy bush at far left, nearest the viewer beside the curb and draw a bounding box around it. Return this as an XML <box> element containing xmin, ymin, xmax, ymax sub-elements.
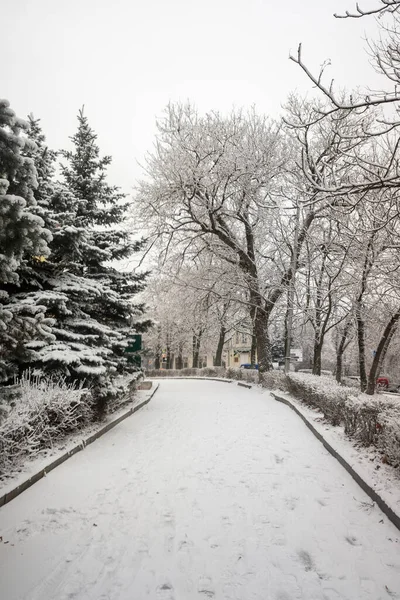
<box><xmin>0</xmin><ymin>373</ymin><xmax>93</xmax><ymax>475</ymax></box>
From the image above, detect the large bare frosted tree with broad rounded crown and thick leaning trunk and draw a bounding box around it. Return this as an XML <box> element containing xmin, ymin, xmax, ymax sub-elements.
<box><xmin>135</xmin><ymin>105</ymin><xmax>310</xmax><ymax>373</ymax></box>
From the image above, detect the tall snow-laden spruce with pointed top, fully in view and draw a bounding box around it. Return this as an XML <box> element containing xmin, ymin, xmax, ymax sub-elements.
<box><xmin>19</xmin><ymin>111</ymin><xmax>147</xmax><ymax>412</ymax></box>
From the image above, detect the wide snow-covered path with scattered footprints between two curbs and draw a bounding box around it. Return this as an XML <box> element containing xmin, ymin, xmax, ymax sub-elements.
<box><xmin>0</xmin><ymin>380</ymin><xmax>400</xmax><ymax>600</ymax></box>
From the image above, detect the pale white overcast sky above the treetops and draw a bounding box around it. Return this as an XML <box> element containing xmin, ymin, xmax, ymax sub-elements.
<box><xmin>0</xmin><ymin>0</ymin><xmax>388</xmax><ymax>191</ymax></box>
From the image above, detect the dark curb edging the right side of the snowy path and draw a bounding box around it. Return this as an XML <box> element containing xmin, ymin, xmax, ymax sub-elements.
<box><xmin>270</xmin><ymin>392</ymin><xmax>400</xmax><ymax>531</ymax></box>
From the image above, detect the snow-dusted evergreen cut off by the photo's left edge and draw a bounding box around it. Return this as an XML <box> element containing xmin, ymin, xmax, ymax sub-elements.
<box><xmin>0</xmin><ymin>100</ymin><xmax>51</xmax><ymax>382</ymax></box>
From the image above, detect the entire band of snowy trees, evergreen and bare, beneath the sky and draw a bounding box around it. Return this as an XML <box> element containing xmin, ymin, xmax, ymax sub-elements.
<box><xmin>0</xmin><ymin>0</ymin><xmax>400</xmax><ymax>466</ymax></box>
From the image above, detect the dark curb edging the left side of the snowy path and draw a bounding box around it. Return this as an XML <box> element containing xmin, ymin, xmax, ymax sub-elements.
<box><xmin>0</xmin><ymin>385</ymin><xmax>159</xmax><ymax>508</ymax></box>
